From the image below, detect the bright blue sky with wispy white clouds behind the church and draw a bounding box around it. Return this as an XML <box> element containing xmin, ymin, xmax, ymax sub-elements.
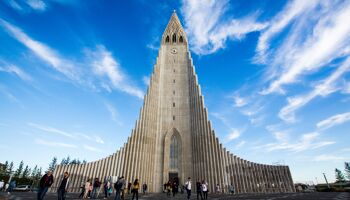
<box><xmin>0</xmin><ymin>0</ymin><xmax>350</xmax><ymax>183</ymax></box>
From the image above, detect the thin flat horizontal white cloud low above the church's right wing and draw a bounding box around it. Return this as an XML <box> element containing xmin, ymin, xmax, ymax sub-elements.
<box><xmin>257</xmin><ymin>132</ymin><xmax>335</xmax><ymax>152</ymax></box>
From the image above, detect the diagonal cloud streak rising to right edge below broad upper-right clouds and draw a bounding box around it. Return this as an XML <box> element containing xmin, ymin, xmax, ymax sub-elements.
<box><xmin>278</xmin><ymin>57</ymin><xmax>350</xmax><ymax>122</ymax></box>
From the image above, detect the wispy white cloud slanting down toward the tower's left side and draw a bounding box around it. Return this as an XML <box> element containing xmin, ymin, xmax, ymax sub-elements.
<box><xmin>89</xmin><ymin>45</ymin><xmax>143</xmax><ymax>99</ymax></box>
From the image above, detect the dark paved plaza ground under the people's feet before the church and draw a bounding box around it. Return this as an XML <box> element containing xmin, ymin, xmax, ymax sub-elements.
<box><xmin>0</xmin><ymin>192</ymin><xmax>350</xmax><ymax>200</ymax></box>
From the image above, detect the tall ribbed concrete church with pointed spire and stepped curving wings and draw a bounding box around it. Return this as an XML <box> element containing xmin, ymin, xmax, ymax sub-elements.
<box><xmin>51</xmin><ymin>12</ymin><xmax>294</xmax><ymax>193</ymax></box>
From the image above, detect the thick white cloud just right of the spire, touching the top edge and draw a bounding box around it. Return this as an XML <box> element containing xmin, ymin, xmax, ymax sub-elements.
<box><xmin>181</xmin><ymin>0</ymin><xmax>266</xmax><ymax>55</ymax></box>
